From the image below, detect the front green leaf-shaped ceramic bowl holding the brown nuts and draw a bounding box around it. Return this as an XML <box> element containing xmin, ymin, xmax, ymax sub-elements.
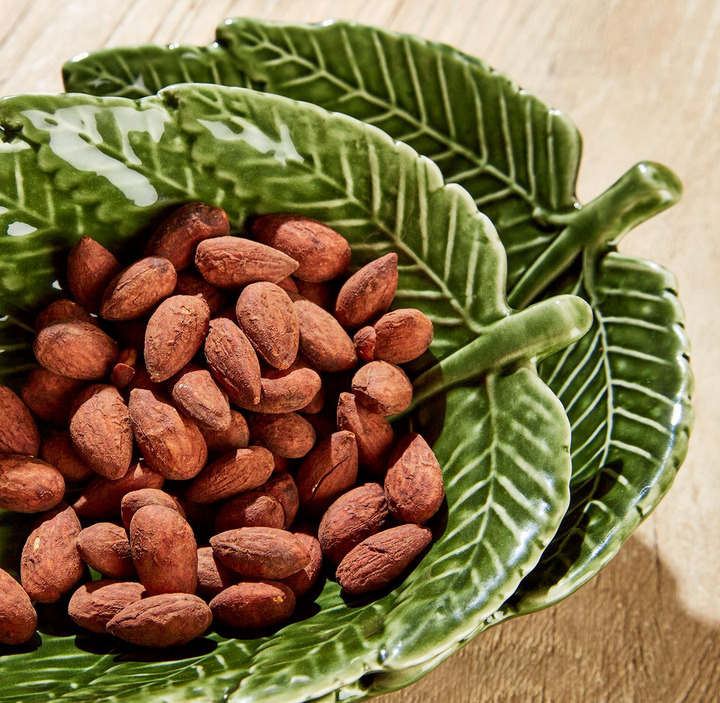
<box><xmin>0</xmin><ymin>85</ymin><xmax>591</xmax><ymax>702</ymax></box>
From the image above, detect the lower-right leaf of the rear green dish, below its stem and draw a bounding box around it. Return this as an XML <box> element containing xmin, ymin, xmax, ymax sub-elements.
<box><xmin>498</xmin><ymin>252</ymin><xmax>692</xmax><ymax>618</ymax></box>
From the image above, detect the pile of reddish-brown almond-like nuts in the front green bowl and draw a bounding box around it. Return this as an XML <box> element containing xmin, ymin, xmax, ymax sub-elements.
<box><xmin>0</xmin><ymin>203</ymin><xmax>444</xmax><ymax>647</ymax></box>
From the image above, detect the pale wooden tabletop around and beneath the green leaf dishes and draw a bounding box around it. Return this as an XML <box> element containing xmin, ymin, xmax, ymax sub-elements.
<box><xmin>0</xmin><ymin>0</ymin><xmax>720</xmax><ymax>703</ymax></box>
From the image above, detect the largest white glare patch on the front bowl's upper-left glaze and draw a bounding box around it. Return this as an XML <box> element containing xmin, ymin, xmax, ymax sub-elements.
<box><xmin>22</xmin><ymin>105</ymin><xmax>170</xmax><ymax>207</ymax></box>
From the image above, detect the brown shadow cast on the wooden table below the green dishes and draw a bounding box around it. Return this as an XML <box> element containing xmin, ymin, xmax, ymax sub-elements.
<box><xmin>378</xmin><ymin>537</ymin><xmax>720</xmax><ymax>703</ymax></box>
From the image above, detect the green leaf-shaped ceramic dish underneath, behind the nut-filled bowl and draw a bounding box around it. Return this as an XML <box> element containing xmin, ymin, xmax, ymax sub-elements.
<box><xmin>64</xmin><ymin>19</ymin><xmax>692</xmax><ymax>613</ymax></box>
